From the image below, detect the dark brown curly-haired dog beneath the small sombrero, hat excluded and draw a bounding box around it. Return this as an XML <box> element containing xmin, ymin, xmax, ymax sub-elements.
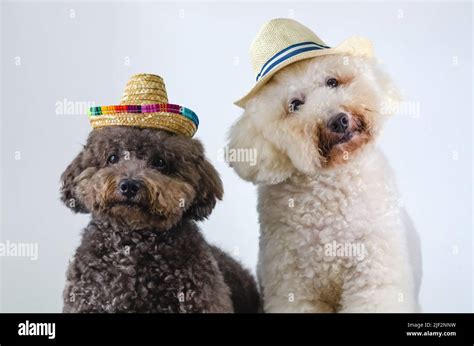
<box><xmin>61</xmin><ymin>126</ymin><xmax>259</xmax><ymax>313</ymax></box>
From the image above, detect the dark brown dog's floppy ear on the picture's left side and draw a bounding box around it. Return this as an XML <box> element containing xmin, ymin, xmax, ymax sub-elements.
<box><xmin>60</xmin><ymin>150</ymin><xmax>89</xmax><ymax>213</ymax></box>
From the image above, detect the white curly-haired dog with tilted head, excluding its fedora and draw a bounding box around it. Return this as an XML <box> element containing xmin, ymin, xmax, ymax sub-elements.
<box><xmin>229</xmin><ymin>55</ymin><xmax>421</xmax><ymax>312</ymax></box>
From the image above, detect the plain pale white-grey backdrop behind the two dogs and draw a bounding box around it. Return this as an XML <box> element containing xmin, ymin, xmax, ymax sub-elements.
<box><xmin>0</xmin><ymin>2</ymin><xmax>473</xmax><ymax>312</ymax></box>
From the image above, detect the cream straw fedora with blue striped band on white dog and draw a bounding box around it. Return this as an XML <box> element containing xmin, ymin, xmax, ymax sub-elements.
<box><xmin>235</xmin><ymin>18</ymin><xmax>373</xmax><ymax>107</ymax></box>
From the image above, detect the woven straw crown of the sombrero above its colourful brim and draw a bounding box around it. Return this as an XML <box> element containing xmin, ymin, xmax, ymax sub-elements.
<box><xmin>120</xmin><ymin>73</ymin><xmax>168</xmax><ymax>105</ymax></box>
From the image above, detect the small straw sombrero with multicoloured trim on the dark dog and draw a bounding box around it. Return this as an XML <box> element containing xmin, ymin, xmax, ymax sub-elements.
<box><xmin>89</xmin><ymin>73</ymin><xmax>199</xmax><ymax>137</ymax></box>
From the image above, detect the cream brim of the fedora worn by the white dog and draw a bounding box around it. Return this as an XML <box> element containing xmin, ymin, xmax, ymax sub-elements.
<box><xmin>234</xmin><ymin>37</ymin><xmax>373</xmax><ymax>108</ymax></box>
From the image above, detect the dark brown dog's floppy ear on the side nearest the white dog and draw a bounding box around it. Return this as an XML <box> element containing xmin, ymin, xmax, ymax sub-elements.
<box><xmin>186</xmin><ymin>158</ymin><xmax>224</xmax><ymax>220</ymax></box>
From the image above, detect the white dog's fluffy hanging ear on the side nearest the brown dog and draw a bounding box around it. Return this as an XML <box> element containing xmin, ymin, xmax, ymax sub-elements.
<box><xmin>226</xmin><ymin>110</ymin><xmax>294</xmax><ymax>184</ymax></box>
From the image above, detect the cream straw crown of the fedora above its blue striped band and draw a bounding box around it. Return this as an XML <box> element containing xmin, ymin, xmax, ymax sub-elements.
<box><xmin>250</xmin><ymin>18</ymin><xmax>326</xmax><ymax>76</ymax></box>
